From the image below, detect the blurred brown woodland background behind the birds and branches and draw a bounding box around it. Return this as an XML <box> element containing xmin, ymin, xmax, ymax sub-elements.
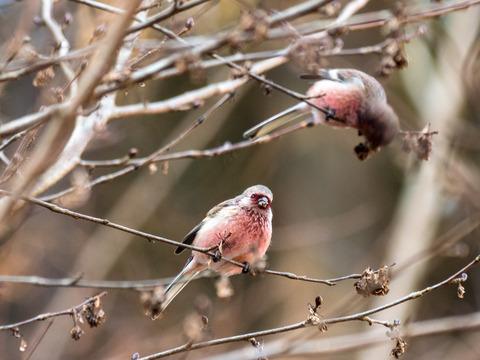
<box><xmin>0</xmin><ymin>0</ymin><xmax>480</xmax><ymax>359</ymax></box>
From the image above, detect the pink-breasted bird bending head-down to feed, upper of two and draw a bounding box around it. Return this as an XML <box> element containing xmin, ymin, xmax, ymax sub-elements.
<box><xmin>243</xmin><ymin>69</ymin><xmax>399</xmax><ymax>150</ymax></box>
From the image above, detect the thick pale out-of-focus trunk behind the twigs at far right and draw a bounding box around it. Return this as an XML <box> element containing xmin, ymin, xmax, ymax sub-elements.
<box><xmin>359</xmin><ymin>2</ymin><xmax>480</xmax><ymax>360</ymax></box>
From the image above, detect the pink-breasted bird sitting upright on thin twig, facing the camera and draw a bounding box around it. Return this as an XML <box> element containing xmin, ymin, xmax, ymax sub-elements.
<box><xmin>151</xmin><ymin>185</ymin><xmax>273</xmax><ymax>319</ymax></box>
